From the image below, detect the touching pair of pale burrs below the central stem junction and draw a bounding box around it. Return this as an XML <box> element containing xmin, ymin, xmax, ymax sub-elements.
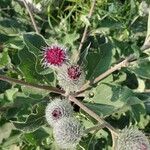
<box><xmin>45</xmin><ymin>98</ymin><xmax>83</xmax><ymax>149</ymax></box>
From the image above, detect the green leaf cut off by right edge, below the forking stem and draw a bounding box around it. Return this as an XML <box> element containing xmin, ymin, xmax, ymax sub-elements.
<box><xmin>129</xmin><ymin>57</ymin><xmax>150</xmax><ymax>79</ymax></box>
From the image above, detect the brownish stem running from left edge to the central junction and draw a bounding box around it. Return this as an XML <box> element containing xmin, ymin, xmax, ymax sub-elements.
<box><xmin>0</xmin><ymin>75</ymin><xmax>64</xmax><ymax>95</ymax></box>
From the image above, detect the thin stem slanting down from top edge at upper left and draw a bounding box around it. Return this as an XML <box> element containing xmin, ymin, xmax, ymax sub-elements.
<box><xmin>23</xmin><ymin>0</ymin><xmax>39</xmax><ymax>33</ymax></box>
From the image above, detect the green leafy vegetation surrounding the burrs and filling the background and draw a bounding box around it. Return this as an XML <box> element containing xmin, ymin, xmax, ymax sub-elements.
<box><xmin>0</xmin><ymin>0</ymin><xmax>150</xmax><ymax>150</ymax></box>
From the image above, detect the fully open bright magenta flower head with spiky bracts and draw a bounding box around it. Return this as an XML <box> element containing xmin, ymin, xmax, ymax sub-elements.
<box><xmin>43</xmin><ymin>45</ymin><xmax>67</xmax><ymax>67</ymax></box>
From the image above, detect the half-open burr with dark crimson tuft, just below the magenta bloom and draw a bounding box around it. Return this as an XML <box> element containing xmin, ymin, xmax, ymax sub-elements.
<box><xmin>57</xmin><ymin>65</ymin><xmax>85</xmax><ymax>92</ymax></box>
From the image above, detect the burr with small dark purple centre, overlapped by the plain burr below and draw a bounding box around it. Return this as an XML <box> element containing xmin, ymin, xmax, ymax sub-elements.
<box><xmin>45</xmin><ymin>99</ymin><xmax>73</xmax><ymax>127</ymax></box>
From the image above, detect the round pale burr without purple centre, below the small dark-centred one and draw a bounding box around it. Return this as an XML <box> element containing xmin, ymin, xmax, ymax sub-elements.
<box><xmin>53</xmin><ymin>117</ymin><xmax>84</xmax><ymax>149</ymax></box>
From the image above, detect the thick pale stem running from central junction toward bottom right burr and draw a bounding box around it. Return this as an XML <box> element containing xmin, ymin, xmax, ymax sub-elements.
<box><xmin>69</xmin><ymin>95</ymin><xmax>118</xmax><ymax>135</ymax></box>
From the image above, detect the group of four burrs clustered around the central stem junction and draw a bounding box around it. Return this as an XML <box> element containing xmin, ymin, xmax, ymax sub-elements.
<box><xmin>43</xmin><ymin>45</ymin><xmax>85</xmax><ymax>149</ymax></box>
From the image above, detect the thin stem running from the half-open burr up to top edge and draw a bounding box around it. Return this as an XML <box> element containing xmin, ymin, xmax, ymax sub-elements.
<box><xmin>75</xmin><ymin>0</ymin><xmax>96</xmax><ymax>62</ymax></box>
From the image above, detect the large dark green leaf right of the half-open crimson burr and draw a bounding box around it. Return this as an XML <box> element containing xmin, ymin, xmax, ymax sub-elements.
<box><xmin>87</xmin><ymin>39</ymin><xmax>112</xmax><ymax>79</ymax></box>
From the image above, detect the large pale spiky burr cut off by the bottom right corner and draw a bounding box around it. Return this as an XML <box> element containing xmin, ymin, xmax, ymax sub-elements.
<box><xmin>116</xmin><ymin>128</ymin><xmax>150</xmax><ymax>150</ymax></box>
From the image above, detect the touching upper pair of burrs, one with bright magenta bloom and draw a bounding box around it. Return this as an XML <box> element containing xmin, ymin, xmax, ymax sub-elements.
<box><xmin>43</xmin><ymin>45</ymin><xmax>85</xmax><ymax>93</ymax></box>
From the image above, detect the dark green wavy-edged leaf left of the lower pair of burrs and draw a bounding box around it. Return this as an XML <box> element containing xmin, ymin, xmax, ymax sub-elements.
<box><xmin>13</xmin><ymin>106</ymin><xmax>45</xmax><ymax>133</ymax></box>
